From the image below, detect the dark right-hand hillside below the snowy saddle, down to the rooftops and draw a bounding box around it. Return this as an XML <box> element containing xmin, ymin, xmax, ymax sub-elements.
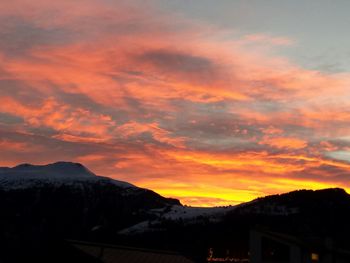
<box><xmin>118</xmin><ymin>188</ymin><xmax>350</xmax><ymax>262</ymax></box>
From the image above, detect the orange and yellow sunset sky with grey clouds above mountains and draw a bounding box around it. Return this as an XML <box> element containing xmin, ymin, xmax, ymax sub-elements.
<box><xmin>0</xmin><ymin>0</ymin><xmax>350</xmax><ymax>206</ymax></box>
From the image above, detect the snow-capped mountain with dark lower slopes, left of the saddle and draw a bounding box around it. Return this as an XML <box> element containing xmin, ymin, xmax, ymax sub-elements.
<box><xmin>0</xmin><ymin>162</ymin><xmax>180</xmax><ymax>262</ymax></box>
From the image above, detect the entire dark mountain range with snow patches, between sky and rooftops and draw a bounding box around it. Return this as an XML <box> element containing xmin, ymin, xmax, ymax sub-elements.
<box><xmin>0</xmin><ymin>162</ymin><xmax>350</xmax><ymax>262</ymax></box>
